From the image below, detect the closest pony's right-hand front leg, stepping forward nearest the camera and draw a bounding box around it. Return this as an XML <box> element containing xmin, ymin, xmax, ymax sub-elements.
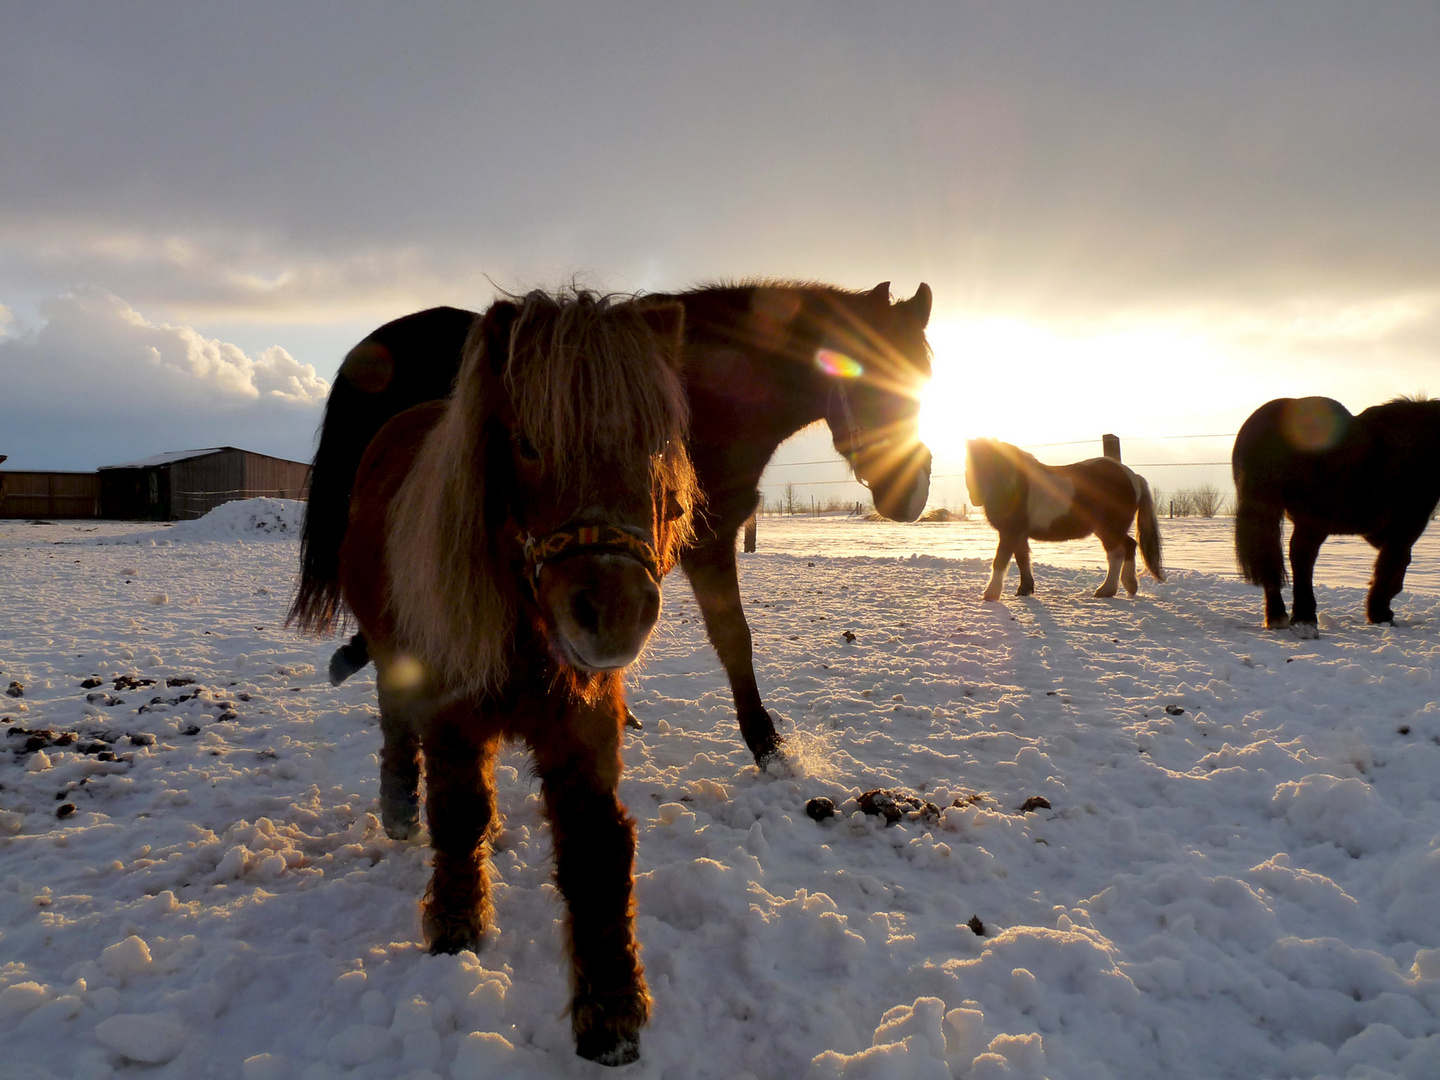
<box><xmin>531</xmin><ymin>694</ymin><xmax>649</xmax><ymax>1066</ymax></box>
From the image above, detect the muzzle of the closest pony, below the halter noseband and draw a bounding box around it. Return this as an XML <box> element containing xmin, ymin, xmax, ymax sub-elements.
<box><xmin>536</xmin><ymin>552</ymin><xmax>660</xmax><ymax>671</ymax></box>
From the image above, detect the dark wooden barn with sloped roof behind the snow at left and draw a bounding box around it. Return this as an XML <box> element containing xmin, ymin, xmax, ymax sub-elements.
<box><xmin>99</xmin><ymin>446</ymin><xmax>310</xmax><ymax>521</ymax></box>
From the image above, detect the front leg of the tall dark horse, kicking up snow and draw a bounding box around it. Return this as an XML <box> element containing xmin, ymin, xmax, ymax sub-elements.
<box><xmin>681</xmin><ymin>537</ymin><xmax>783</xmax><ymax>769</ymax></box>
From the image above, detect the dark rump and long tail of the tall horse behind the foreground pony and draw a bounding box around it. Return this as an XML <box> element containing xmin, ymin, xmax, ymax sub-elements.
<box><xmin>285</xmin><ymin>308</ymin><xmax>475</xmax><ymax>639</ymax></box>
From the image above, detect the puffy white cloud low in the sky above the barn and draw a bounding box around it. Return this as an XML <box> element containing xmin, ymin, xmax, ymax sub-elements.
<box><xmin>0</xmin><ymin>289</ymin><xmax>330</xmax><ymax>409</ymax></box>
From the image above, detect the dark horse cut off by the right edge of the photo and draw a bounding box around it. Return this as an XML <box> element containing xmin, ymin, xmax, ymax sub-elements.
<box><xmin>1230</xmin><ymin>397</ymin><xmax>1440</xmax><ymax>638</ymax></box>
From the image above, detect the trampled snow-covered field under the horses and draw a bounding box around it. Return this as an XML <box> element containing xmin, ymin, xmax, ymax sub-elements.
<box><xmin>0</xmin><ymin>501</ymin><xmax>1440</xmax><ymax>1080</ymax></box>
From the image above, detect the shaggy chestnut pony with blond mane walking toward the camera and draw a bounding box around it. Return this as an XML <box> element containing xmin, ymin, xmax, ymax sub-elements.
<box><xmin>332</xmin><ymin>292</ymin><xmax>696</xmax><ymax>1066</ymax></box>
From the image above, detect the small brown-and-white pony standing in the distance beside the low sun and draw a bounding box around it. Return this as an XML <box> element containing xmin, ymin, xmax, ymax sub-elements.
<box><xmin>965</xmin><ymin>439</ymin><xmax>1165</xmax><ymax>600</ymax></box>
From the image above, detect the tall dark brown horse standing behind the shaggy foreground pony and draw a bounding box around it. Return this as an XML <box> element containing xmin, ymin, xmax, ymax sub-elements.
<box><xmin>291</xmin><ymin>282</ymin><xmax>930</xmax><ymax>768</ymax></box>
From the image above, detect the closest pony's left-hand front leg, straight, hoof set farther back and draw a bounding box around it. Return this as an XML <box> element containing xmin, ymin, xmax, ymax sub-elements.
<box><xmin>420</xmin><ymin>720</ymin><xmax>498</xmax><ymax>953</ymax></box>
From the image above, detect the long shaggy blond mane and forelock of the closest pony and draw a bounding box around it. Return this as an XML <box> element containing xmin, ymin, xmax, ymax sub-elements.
<box><xmin>386</xmin><ymin>289</ymin><xmax>696</xmax><ymax>693</ymax></box>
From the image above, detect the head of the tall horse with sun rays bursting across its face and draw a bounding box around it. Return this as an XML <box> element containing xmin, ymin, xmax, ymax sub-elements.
<box><xmin>815</xmin><ymin>281</ymin><xmax>930</xmax><ymax>521</ymax></box>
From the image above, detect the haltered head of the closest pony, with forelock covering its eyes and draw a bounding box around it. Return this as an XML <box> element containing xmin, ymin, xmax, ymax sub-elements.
<box><xmin>472</xmin><ymin>292</ymin><xmax>696</xmax><ymax>672</ymax></box>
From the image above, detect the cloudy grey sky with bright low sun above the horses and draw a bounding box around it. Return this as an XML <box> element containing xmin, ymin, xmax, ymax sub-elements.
<box><xmin>0</xmin><ymin>0</ymin><xmax>1440</xmax><ymax>506</ymax></box>
